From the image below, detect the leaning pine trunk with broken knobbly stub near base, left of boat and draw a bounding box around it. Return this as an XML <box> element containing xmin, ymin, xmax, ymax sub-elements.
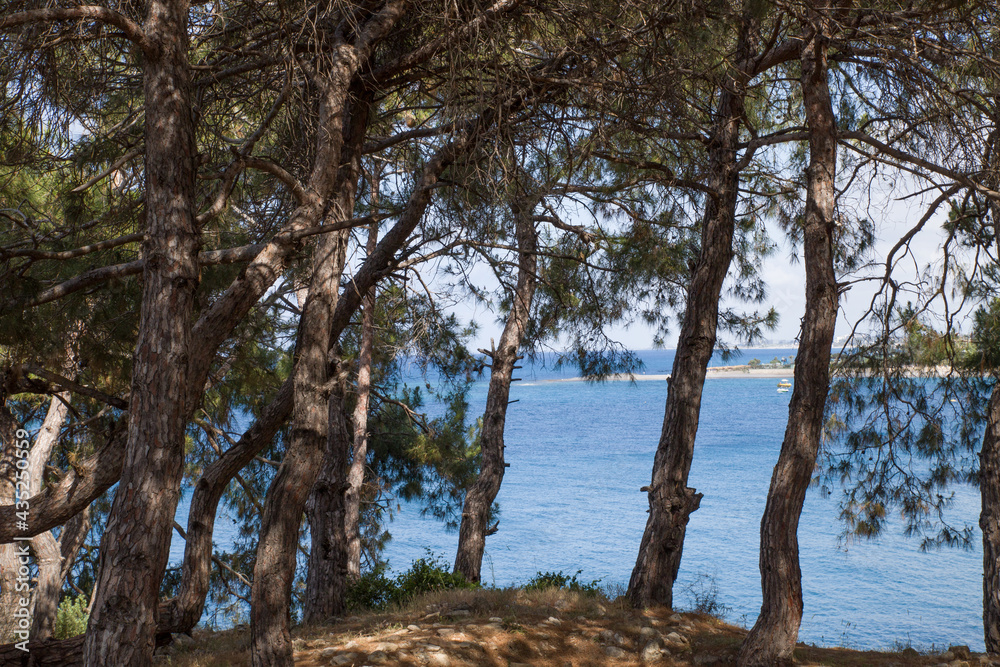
<box><xmin>628</xmin><ymin>15</ymin><xmax>749</xmax><ymax>607</ymax></box>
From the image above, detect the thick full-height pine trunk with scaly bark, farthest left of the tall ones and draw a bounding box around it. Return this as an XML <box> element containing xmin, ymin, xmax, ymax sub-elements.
<box><xmin>84</xmin><ymin>0</ymin><xmax>199</xmax><ymax>666</ymax></box>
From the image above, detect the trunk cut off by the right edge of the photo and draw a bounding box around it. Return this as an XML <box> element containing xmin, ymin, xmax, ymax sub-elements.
<box><xmin>979</xmin><ymin>383</ymin><xmax>1000</xmax><ymax>655</ymax></box>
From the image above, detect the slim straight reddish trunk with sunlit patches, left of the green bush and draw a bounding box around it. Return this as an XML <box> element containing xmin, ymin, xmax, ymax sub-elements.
<box><xmin>344</xmin><ymin>219</ymin><xmax>378</xmax><ymax>583</ymax></box>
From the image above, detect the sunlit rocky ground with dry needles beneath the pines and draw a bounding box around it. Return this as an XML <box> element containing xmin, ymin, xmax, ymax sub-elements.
<box><xmin>157</xmin><ymin>590</ymin><xmax>1000</xmax><ymax>667</ymax></box>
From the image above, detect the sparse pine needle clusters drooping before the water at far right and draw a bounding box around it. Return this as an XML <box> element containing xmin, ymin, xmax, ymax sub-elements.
<box><xmin>820</xmin><ymin>303</ymin><xmax>989</xmax><ymax>549</ymax></box>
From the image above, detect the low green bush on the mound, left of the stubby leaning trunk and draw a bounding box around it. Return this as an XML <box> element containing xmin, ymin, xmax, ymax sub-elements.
<box><xmin>347</xmin><ymin>555</ymin><xmax>479</xmax><ymax>609</ymax></box>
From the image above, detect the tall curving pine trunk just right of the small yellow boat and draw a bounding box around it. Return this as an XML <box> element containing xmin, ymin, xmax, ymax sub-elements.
<box><xmin>737</xmin><ymin>7</ymin><xmax>838</xmax><ymax>667</ymax></box>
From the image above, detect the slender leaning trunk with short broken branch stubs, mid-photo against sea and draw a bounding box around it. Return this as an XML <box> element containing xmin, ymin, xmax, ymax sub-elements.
<box><xmin>455</xmin><ymin>199</ymin><xmax>538</xmax><ymax>582</ymax></box>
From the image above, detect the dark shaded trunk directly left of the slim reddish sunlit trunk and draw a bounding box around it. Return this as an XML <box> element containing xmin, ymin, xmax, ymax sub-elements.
<box><xmin>302</xmin><ymin>386</ymin><xmax>351</xmax><ymax>623</ymax></box>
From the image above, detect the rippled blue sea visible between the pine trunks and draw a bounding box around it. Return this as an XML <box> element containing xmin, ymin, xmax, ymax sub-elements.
<box><xmin>171</xmin><ymin>348</ymin><xmax>984</xmax><ymax>651</ymax></box>
